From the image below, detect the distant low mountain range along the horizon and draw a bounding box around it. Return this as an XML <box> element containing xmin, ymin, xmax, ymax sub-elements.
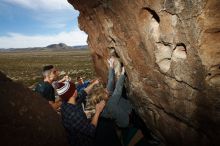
<box><xmin>0</xmin><ymin>43</ymin><xmax>88</xmax><ymax>52</ymax></box>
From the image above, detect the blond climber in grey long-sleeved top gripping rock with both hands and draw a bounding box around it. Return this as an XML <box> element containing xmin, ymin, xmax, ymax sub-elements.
<box><xmin>91</xmin><ymin>58</ymin><xmax>137</xmax><ymax>146</ymax></box>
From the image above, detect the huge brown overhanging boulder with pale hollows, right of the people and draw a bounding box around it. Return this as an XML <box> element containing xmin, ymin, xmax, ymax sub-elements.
<box><xmin>68</xmin><ymin>0</ymin><xmax>220</xmax><ymax>146</ymax></box>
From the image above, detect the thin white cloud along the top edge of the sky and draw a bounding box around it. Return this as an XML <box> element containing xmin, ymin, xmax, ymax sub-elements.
<box><xmin>3</xmin><ymin>0</ymin><xmax>73</xmax><ymax>10</ymax></box>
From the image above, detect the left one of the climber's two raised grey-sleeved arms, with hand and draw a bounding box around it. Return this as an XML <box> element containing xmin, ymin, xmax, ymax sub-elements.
<box><xmin>107</xmin><ymin>58</ymin><xmax>115</xmax><ymax>95</ymax></box>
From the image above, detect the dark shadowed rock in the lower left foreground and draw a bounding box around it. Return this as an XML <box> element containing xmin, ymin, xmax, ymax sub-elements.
<box><xmin>0</xmin><ymin>72</ymin><xmax>68</xmax><ymax>146</ymax></box>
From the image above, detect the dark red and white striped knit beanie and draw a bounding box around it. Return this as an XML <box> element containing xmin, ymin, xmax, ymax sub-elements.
<box><xmin>56</xmin><ymin>81</ymin><xmax>76</xmax><ymax>101</ymax></box>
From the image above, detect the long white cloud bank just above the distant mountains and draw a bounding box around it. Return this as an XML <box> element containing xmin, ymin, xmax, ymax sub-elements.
<box><xmin>0</xmin><ymin>29</ymin><xmax>87</xmax><ymax>48</ymax></box>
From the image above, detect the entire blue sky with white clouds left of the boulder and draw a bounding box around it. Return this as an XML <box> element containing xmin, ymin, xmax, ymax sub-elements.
<box><xmin>0</xmin><ymin>0</ymin><xmax>87</xmax><ymax>48</ymax></box>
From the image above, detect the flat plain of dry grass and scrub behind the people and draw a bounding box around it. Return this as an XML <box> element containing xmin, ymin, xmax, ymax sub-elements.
<box><xmin>0</xmin><ymin>50</ymin><xmax>94</xmax><ymax>86</ymax></box>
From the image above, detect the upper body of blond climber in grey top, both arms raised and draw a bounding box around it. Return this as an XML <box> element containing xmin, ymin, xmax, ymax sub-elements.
<box><xmin>92</xmin><ymin>58</ymin><xmax>132</xmax><ymax>127</ymax></box>
